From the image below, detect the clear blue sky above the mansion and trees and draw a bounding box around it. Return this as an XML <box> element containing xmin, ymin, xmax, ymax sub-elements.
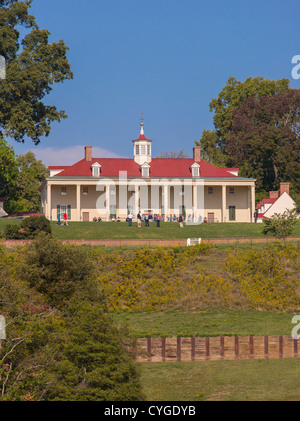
<box><xmin>9</xmin><ymin>0</ymin><xmax>300</xmax><ymax>165</ymax></box>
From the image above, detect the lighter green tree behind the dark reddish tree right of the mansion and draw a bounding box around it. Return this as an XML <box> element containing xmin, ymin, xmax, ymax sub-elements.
<box><xmin>195</xmin><ymin>77</ymin><xmax>289</xmax><ymax>166</ymax></box>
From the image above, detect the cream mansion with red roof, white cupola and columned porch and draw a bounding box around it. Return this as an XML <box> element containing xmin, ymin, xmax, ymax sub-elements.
<box><xmin>41</xmin><ymin>123</ymin><xmax>255</xmax><ymax>223</ymax></box>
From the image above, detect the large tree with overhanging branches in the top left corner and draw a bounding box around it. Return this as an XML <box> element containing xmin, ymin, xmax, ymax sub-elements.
<box><xmin>0</xmin><ymin>0</ymin><xmax>73</xmax><ymax>145</ymax></box>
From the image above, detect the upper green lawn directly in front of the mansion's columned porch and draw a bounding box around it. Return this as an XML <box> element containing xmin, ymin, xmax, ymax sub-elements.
<box><xmin>0</xmin><ymin>218</ymin><xmax>300</xmax><ymax>240</ymax></box>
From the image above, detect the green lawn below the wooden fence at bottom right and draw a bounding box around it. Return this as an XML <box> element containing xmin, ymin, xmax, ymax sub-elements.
<box><xmin>138</xmin><ymin>358</ymin><xmax>300</xmax><ymax>402</ymax></box>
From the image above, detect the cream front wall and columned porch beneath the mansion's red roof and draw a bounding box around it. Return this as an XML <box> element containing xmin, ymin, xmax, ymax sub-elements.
<box><xmin>41</xmin><ymin>177</ymin><xmax>255</xmax><ymax>222</ymax></box>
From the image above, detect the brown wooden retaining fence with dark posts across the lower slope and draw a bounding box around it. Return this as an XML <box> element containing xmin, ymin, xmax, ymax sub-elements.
<box><xmin>125</xmin><ymin>335</ymin><xmax>300</xmax><ymax>362</ymax></box>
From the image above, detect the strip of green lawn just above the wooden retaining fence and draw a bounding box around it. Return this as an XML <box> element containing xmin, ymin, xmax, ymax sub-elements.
<box><xmin>114</xmin><ymin>308</ymin><xmax>295</xmax><ymax>338</ymax></box>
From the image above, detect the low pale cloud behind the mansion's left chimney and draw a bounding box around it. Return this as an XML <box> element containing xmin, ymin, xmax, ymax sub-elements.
<box><xmin>33</xmin><ymin>145</ymin><xmax>124</xmax><ymax>167</ymax></box>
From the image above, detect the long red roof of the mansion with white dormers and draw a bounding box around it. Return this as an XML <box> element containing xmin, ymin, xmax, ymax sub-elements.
<box><xmin>49</xmin><ymin>158</ymin><xmax>237</xmax><ymax>178</ymax></box>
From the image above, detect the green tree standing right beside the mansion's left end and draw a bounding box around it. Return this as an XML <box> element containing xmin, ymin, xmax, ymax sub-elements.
<box><xmin>6</xmin><ymin>151</ymin><xmax>49</xmax><ymax>213</ymax></box>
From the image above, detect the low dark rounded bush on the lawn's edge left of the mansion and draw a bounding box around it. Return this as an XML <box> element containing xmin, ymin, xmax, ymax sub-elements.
<box><xmin>4</xmin><ymin>215</ymin><xmax>51</xmax><ymax>240</ymax></box>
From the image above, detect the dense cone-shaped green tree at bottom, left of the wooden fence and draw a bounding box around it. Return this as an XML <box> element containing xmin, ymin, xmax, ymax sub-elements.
<box><xmin>45</xmin><ymin>300</ymin><xmax>143</xmax><ymax>401</ymax></box>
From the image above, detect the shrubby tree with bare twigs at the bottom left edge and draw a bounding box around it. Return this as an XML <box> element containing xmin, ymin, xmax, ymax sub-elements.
<box><xmin>0</xmin><ymin>241</ymin><xmax>63</xmax><ymax>401</ymax></box>
